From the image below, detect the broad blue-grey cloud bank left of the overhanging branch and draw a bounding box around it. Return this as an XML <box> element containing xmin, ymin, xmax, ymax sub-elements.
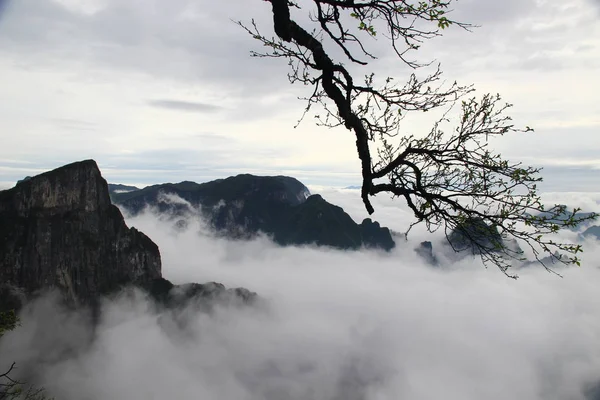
<box><xmin>0</xmin><ymin>0</ymin><xmax>286</xmax><ymax>96</ymax></box>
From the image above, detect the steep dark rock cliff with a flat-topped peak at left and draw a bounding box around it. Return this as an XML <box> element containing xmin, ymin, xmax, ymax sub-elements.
<box><xmin>0</xmin><ymin>160</ymin><xmax>161</xmax><ymax>304</ymax></box>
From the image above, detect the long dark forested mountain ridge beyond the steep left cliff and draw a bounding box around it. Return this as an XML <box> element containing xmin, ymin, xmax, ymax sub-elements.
<box><xmin>112</xmin><ymin>174</ymin><xmax>395</xmax><ymax>250</ymax></box>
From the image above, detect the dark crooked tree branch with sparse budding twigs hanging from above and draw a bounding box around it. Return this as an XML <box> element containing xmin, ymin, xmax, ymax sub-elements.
<box><xmin>238</xmin><ymin>0</ymin><xmax>595</xmax><ymax>278</ymax></box>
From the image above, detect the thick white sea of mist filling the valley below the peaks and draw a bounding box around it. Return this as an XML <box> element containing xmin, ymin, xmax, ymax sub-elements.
<box><xmin>0</xmin><ymin>190</ymin><xmax>600</xmax><ymax>400</ymax></box>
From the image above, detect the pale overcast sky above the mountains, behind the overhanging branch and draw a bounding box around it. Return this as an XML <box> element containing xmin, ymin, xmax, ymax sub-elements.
<box><xmin>0</xmin><ymin>0</ymin><xmax>600</xmax><ymax>191</ymax></box>
